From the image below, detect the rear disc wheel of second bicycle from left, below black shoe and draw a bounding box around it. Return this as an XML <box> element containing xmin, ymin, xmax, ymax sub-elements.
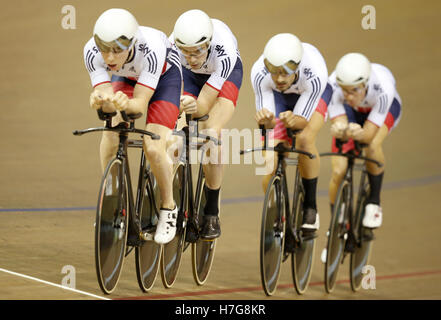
<box><xmin>191</xmin><ymin>178</ymin><xmax>221</xmax><ymax>286</ymax></box>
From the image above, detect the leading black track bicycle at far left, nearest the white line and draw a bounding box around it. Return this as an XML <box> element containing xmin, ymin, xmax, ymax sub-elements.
<box><xmin>73</xmin><ymin>110</ymin><xmax>166</xmax><ymax>294</ymax></box>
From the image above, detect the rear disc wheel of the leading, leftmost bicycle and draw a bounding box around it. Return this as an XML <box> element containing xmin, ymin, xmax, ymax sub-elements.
<box><xmin>135</xmin><ymin>171</ymin><xmax>162</xmax><ymax>292</ymax></box>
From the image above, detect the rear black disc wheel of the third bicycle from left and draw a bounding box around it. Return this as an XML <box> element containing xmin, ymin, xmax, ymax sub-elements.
<box><xmin>291</xmin><ymin>187</ymin><xmax>315</xmax><ymax>294</ymax></box>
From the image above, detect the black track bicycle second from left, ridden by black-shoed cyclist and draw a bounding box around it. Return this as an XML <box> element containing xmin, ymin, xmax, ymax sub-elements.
<box><xmin>161</xmin><ymin>115</ymin><xmax>220</xmax><ymax>288</ymax></box>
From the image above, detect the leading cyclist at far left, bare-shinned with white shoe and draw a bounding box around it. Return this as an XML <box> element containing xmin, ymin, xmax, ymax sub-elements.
<box><xmin>84</xmin><ymin>8</ymin><xmax>182</xmax><ymax>244</ymax></box>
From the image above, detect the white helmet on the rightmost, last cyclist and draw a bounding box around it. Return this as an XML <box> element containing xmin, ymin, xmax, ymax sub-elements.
<box><xmin>335</xmin><ymin>52</ymin><xmax>371</xmax><ymax>86</ymax></box>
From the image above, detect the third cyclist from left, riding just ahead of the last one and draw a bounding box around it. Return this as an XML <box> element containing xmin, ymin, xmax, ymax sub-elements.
<box><xmin>251</xmin><ymin>33</ymin><xmax>332</xmax><ymax>243</ymax></box>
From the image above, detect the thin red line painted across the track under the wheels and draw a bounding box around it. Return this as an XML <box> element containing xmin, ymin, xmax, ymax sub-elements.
<box><xmin>115</xmin><ymin>270</ymin><xmax>441</xmax><ymax>300</ymax></box>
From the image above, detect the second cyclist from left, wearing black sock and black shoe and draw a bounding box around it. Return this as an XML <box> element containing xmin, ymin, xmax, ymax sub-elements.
<box><xmin>170</xmin><ymin>10</ymin><xmax>243</xmax><ymax>240</ymax></box>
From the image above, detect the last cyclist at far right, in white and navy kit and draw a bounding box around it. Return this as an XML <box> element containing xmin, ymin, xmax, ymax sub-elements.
<box><xmin>328</xmin><ymin>53</ymin><xmax>401</xmax><ymax>228</ymax></box>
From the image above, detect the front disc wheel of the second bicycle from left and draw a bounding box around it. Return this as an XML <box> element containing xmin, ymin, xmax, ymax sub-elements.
<box><xmin>161</xmin><ymin>164</ymin><xmax>186</xmax><ymax>288</ymax></box>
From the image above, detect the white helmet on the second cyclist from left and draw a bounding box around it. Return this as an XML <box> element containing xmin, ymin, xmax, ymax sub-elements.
<box><xmin>173</xmin><ymin>9</ymin><xmax>213</xmax><ymax>48</ymax></box>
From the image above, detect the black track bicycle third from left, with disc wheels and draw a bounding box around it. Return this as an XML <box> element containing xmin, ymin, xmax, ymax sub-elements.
<box><xmin>240</xmin><ymin>126</ymin><xmax>316</xmax><ymax>296</ymax></box>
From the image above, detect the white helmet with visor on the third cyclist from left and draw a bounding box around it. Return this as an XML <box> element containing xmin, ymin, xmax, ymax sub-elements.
<box><xmin>263</xmin><ymin>33</ymin><xmax>303</xmax><ymax>74</ymax></box>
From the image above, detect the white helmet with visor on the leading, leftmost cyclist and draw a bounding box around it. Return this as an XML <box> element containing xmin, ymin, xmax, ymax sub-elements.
<box><xmin>93</xmin><ymin>8</ymin><xmax>139</xmax><ymax>52</ymax></box>
